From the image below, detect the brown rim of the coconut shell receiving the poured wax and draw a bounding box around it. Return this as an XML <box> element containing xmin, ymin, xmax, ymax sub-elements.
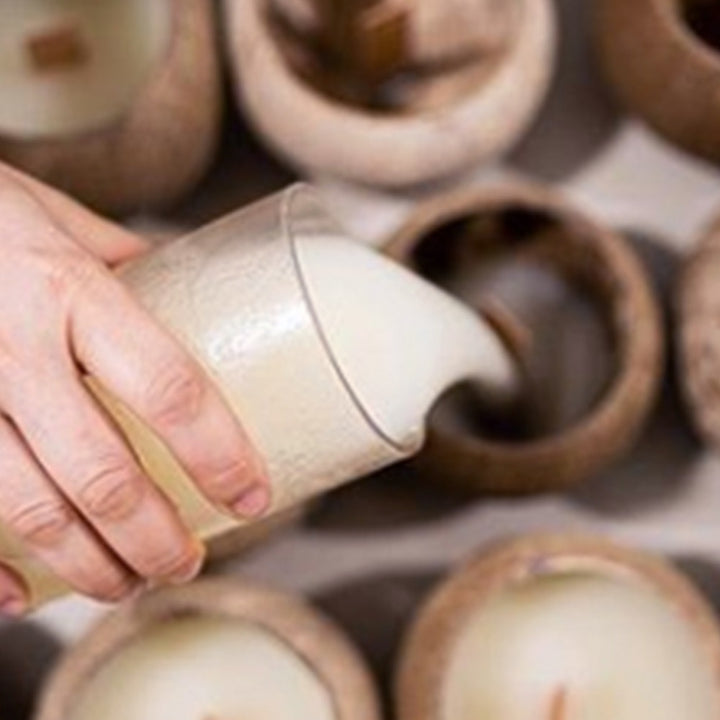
<box><xmin>382</xmin><ymin>182</ymin><xmax>665</xmax><ymax>492</ymax></box>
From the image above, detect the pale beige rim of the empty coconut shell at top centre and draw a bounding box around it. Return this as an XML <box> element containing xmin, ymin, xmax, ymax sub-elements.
<box><xmin>225</xmin><ymin>0</ymin><xmax>557</xmax><ymax>187</ymax></box>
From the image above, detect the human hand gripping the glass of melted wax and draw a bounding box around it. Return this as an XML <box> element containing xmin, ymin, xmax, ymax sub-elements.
<box><xmin>0</xmin><ymin>165</ymin><xmax>270</xmax><ymax>615</ymax></box>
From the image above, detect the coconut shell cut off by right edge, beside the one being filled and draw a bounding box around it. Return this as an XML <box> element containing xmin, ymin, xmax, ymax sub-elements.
<box><xmin>678</xmin><ymin>214</ymin><xmax>720</xmax><ymax>448</ymax></box>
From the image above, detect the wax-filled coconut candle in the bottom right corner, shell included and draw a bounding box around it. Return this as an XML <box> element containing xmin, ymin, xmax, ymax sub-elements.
<box><xmin>398</xmin><ymin>537</ymin><xmax>720</xmax><ymax>720</ymax></box>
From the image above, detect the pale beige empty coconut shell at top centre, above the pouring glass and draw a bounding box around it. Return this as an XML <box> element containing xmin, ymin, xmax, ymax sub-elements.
<box><xmin>225</xmin><ymin>0</ymin><xmax>555</xmax><ymax>187</ymax></box>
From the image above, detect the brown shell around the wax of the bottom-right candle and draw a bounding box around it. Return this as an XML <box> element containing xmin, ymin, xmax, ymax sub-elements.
<box><xmin>396</xmin><ymin>535</ymin><xmax>720</xmax><ymax>720</ymax></box>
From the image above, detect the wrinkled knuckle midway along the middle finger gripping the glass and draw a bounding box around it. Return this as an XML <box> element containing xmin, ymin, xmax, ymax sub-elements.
<box><xmin>78</xmin><ymin>460</ymin><xmax>145</xmax><ymax>521</ymax></box>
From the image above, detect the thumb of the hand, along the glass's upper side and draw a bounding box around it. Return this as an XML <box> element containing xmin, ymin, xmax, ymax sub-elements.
<box><xmin>0</xmin><ymin>165</ymin><xmax>148</xmax><ymax>265</ymax></box>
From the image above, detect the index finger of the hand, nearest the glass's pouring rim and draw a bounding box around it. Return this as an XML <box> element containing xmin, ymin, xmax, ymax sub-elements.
<box><xmin>71</xmin><ymin>268</ymin><xmax>270</xmax><ymax>517</ymax></box>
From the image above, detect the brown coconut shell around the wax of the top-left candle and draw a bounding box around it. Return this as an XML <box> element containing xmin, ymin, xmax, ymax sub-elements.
<box><xmin>0</xmin><ymin>0</ymin><xmax>221</xmax><ymax>214</ymax></box>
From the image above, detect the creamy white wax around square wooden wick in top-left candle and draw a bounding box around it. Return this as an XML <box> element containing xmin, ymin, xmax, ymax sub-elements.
<box><xmin>0</xmin><ymin>0</ymin><xmax>171</xmax><ymax>138</ymax></box>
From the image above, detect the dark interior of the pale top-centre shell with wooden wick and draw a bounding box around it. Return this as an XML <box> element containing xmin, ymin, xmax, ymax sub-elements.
<box><xmin>267</xmin><ymin>0</ymin><xmax>517</xmax><ymax>114</ymax></box>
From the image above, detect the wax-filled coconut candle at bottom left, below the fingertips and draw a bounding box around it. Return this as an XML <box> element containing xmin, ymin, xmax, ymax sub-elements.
<box><xmin>39</xmin><ymin>581</ymin><xmax>379</xmax><ymax>720</ymax></box>
